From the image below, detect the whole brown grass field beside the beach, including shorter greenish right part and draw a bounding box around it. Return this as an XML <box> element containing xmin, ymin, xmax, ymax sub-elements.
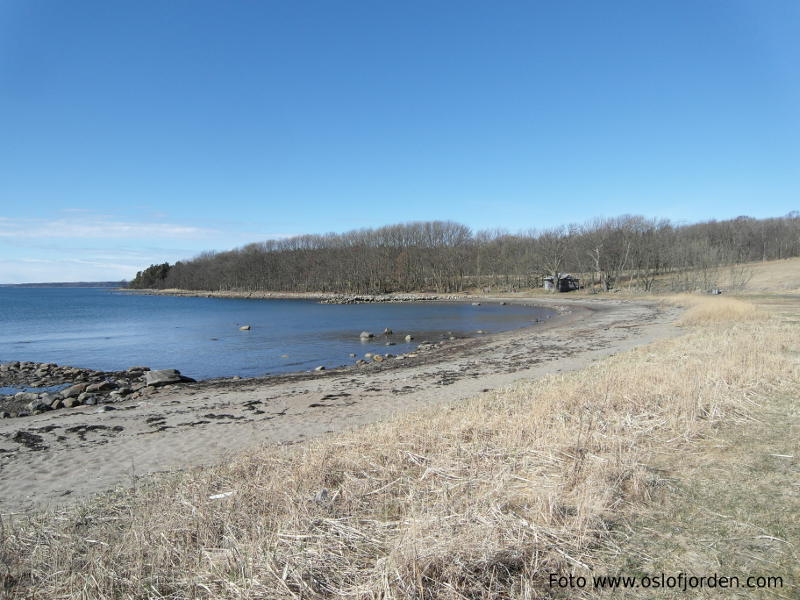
<box><xmin>0</xmin><ymin>296</ymin><xmax>800</xmax><ymax>600</ymax></box>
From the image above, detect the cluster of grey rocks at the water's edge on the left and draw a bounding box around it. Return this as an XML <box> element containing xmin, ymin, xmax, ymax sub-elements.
<box><xmin>0</xmin><ymin>361</ymin><xmax>195</xmax><ymax>419</ymax></box>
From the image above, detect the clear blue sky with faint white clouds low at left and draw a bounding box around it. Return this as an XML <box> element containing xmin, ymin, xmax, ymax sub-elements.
<box><xmin>0</xmin><ymin>0</ymin><xmax>800</xmax><ymax>283</ymax></box>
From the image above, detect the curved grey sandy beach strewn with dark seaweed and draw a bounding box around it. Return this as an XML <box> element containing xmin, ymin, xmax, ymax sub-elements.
<box><xmin>0</xmin><ymin>298</ymin><xmax>679</xmax><ymax>514</ymax></box>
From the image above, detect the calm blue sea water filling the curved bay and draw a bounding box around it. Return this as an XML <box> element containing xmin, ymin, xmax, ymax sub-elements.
<box><xmin>0</xmin><ymin>288</ymin><xmax>552</xmax><ymax>379</ymax></box>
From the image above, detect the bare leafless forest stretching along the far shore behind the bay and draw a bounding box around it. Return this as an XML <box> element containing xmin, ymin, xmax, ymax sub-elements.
<box><xmin>129</xmin><ymin>211</ymin><xmax>800</xmax><ymax>294</ymax></box>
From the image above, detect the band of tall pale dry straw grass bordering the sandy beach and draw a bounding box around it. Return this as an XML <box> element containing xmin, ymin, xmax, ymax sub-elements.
<box><xmin>0</xmin><ymin>299</ymin><xmax>799</xmax><ymax>600</ymax></box>
